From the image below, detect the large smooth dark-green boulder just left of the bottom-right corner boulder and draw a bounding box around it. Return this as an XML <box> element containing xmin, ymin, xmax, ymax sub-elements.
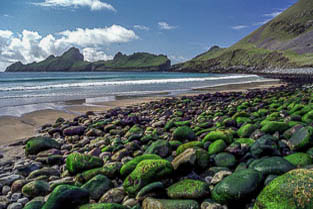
<box><xmin>212</xmin><ymin>169</ymin><xmax>262</xmax><ymax>206</ymax></box>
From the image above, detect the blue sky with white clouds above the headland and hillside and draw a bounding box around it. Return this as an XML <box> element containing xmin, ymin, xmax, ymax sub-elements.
<box><xmin>0</xmin><ymin>0</ymin><xmax>297</xmax><ymax>71</ymax></box>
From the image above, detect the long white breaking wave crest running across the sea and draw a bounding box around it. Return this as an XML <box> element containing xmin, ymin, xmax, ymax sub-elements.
<box><xmin>0</xmin><ymin>75</ymin><xmax>258</xmax><ymax>91</ymax></box>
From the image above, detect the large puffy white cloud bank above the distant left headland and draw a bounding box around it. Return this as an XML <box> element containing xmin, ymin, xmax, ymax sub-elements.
<box><xmin>0</xmin><ymin>25</ymin><xmax>139</xmax><ymax>70</ymax></box>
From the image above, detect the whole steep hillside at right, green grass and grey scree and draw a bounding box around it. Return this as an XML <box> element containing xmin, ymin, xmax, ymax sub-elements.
<box><xmin>173</xmin><ymin>0</ymin><xmax>313</xmax><ymax>72</ymax></box>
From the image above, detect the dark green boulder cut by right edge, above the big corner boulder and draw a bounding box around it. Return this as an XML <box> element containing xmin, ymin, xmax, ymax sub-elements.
<box><xmin>289</xmin><ymin>126</ymin><xmax>313</xmax><ymax>151</ymax></box>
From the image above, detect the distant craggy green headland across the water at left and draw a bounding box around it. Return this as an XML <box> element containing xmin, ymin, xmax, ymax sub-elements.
<box><xmin>6</xmin><ymin>47</ymin><xmax>171</xmax><ymax>72</ymax></box>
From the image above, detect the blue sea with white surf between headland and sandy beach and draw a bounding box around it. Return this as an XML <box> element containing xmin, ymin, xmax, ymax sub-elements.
<box><xmin>0</xmin><ymin>72</ymin><xmax>265</xmax><ymax>116</ymax></box>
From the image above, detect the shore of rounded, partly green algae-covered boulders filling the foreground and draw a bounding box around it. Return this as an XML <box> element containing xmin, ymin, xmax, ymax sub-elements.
<box><xmin>0</xmin><ymin>85</ymin><xmax>313</xmax><ymax>209</ymax></box>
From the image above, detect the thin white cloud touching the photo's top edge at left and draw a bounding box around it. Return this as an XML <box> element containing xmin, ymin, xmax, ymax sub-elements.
<box><xmin>32</xmin><ymin>0</ymin><xmax>116</xmax><ymax>11</ymax></box>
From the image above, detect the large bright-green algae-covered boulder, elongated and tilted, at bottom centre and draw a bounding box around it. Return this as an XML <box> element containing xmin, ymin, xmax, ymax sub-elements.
<box><xmin>123</xmin><ymin>160</ymin><xmax>173</xmax><ymax>195</ymax></box>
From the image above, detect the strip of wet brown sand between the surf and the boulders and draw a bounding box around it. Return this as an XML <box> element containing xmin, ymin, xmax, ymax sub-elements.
<box><xmin>0</xmin><ymin>80</ymin><xmax>284</xmax><ymax>146</ymax></box>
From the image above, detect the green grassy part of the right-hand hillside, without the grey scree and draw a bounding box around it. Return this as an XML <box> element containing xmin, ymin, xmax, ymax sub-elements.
<box><xmin>182</xmin><ymin>0</ymin><xmax>313</xmax><ymax>70</ymax></box>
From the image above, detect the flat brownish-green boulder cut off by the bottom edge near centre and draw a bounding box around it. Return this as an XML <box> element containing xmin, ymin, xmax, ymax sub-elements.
<box><xmin>142</xmin><ymin>197</ymin><xmax>199</xmax><ymax>209</ymax></box>
